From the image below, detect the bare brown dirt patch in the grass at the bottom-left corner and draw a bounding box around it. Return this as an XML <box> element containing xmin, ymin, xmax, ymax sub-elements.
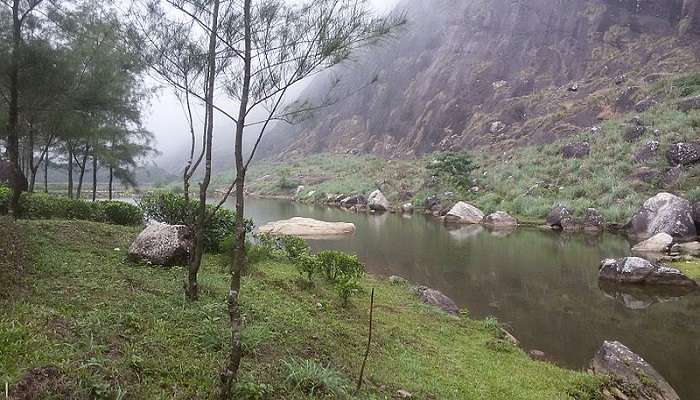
<box><xmin>10</xmin><ymin>366</ymin><xmax>74</xmax><ymax>400</ymax></box>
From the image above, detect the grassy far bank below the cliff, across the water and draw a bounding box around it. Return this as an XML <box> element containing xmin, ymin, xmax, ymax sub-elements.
<box><xmin>226</xmin><ymin>74</ymin><xmax>700</xmax><ymax>223</ymax></box>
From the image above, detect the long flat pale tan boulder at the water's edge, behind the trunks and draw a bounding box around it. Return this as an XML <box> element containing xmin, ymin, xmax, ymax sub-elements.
<box><xmin>258</xmin><ymin>217</ymin><xmax>355</xmax><ymax>238</ymax></box>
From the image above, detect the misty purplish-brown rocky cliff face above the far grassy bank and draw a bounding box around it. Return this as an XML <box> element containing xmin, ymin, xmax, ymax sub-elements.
<box><xmin>264</xmin><ymin>0</ymin><xmax>700</xmax><ymax>157</ymax></box>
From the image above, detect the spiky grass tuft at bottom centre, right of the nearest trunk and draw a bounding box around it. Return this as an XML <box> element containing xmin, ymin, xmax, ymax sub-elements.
<box><xmin>282</xmin><ymin>359</ymin><xmax>350</xmax><ymax>397</ymax></box>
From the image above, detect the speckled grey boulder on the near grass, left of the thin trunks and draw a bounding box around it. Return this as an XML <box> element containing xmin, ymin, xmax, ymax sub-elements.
<box><xmin>129</xmin><ymin>222</ymin><xmax>194</xmax><ymax>266</ymax></box>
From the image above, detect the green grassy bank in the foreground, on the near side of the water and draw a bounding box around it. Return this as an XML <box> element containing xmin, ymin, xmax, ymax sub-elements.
<box><xmin>0</xmin><ymin>221</ymin><xmax>601</xmax><ymax>400</ymax></box>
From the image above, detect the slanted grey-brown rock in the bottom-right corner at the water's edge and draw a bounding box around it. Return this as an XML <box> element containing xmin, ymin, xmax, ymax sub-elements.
<box><xmin>591</xmin><ymin>341</ymin><xmax>680</xmax><ymax>400</ymax></box>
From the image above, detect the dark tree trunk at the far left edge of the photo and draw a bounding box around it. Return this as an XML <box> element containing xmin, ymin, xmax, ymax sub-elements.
<box><xmin>7</xmin><ymin>0</ymin><xmax>22</xmax><ymax>218</ymax></box>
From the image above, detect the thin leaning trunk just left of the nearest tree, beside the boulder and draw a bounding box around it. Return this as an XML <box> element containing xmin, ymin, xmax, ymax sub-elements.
<box><xmin>185</xmin><ymin>0</ymin><xmax>220</xmax><ymax>300</ymax></box>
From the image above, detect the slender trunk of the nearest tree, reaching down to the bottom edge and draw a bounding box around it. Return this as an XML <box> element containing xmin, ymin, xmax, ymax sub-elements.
<box><xmin>221</xmin><ymin>0</ymin><xmax>252</xmax><ymax>400</ymax></box>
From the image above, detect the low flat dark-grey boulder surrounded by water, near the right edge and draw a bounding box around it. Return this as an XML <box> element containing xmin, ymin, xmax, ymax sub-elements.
<box><xmin>598</xmin><ymin>257</ymin><xmax>697</xmax><ymax>288</ymax></box>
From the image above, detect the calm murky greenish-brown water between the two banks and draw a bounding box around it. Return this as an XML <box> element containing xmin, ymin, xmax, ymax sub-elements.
<box><xmin>237</xmin><ymin>199</ymin><xmax>700</xmax><ymax>399</ymax></box>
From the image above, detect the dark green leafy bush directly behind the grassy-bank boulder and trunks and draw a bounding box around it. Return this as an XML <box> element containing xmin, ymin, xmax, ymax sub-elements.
<box><xmin>138</xmin><ymin>192</ymin><xmax>253</xmax><ymax>252</ymax></box>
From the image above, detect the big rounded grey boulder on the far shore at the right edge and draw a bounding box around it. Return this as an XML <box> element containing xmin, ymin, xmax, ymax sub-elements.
<box><xmin>625</xmin><ymin>193</ymin><xmax>697</xmax><ymax>239</ymax></box>
